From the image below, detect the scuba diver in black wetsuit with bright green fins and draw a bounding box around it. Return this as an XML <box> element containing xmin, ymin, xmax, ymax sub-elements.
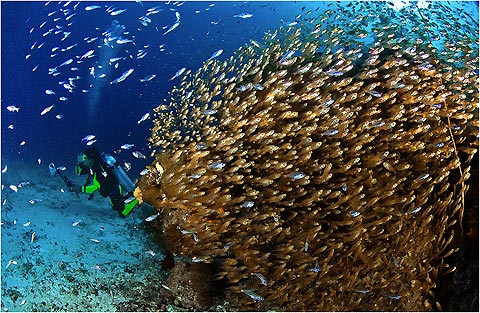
<box><xmin>69</xmin><ymin>146</ymin><xmax>138</xmax><ymax>217</ymax></box>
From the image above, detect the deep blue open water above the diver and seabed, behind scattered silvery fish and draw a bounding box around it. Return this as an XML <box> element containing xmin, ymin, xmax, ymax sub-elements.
<box><xmin>1</xmin><ymin>1</ymin><xmax>326</xmax><ymax>170</ymax></box>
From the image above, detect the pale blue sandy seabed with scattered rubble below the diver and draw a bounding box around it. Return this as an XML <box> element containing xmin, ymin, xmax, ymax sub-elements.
<box><xmin>1</xmin><ymin>160</ymin><xmax>164</xmax><ymax>311</ymax></box>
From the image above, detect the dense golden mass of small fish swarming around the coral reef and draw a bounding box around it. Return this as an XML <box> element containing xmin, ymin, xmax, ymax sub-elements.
<box><xmin>138</xmin><ymin>3</ymin><xmax>478</xmax><ymax>311</ymax></box>
